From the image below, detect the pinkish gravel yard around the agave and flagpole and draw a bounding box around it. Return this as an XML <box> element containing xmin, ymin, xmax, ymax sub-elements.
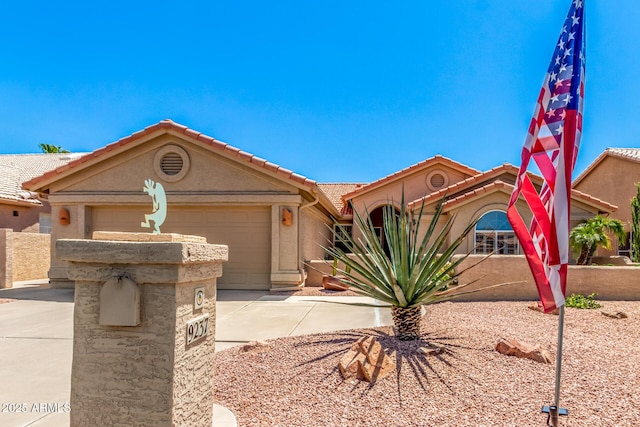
<box><xmin>214</xmin><ymin>301</ymin><xmax>640</xmax><ymax>427</ymax></box>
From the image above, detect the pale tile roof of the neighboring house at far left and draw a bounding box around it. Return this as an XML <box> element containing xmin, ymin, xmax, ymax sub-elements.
<box><xmin>0</xmin><ymin>153</ymin><xmax>82</xmax><ymax>205</ymax></box>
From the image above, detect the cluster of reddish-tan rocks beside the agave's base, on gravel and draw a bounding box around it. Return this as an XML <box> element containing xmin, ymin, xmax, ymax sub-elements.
<box><xmin>338</xmin><ymin>337</ymin><xmax>396</xmax><ymax>384</ymax></box>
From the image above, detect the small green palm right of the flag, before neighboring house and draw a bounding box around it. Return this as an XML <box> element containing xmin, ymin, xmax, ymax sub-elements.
<box><xmin>569</xmin><ymin>215</ymin><xmax>627</xmax><ymax>265</ymax></box>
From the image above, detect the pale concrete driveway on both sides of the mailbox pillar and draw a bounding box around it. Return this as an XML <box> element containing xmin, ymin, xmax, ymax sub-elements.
<box><xmin>0</xmin><ymin>281</ymin><xmax>392</xmax><ymax>427</ymax></box>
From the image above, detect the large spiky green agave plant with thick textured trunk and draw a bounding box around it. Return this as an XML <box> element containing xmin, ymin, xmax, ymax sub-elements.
<box><xmin>324</xmin><ymin>192</ymin><xmax>484</xmax><ymax>340</ymax></box>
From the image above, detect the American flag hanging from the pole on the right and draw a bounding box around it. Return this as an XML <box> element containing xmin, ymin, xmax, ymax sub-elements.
<box><xmin>507</xmin><ymin>0</ymin><xmax>585</xmax><ymax>313</ymax></box>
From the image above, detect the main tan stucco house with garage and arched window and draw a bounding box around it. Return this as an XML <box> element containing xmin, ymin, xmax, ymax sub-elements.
<box><xmin>24</xmin><ymin>120</ymin><xmax>616</xmax><ymax>290</ymax></box>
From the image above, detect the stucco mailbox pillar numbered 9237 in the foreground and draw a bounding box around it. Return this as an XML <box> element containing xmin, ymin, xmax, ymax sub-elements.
<box><xmin>56</xmin><ymin>233</ymin><xmax>228</xmax><ymax>427</ymax></box>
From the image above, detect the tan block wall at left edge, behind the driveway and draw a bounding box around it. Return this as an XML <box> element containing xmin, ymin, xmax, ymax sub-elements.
<box><xmin>0</xmin><ymin>228</ymin><xmax>51</xmax><ymax>288</ymax></box>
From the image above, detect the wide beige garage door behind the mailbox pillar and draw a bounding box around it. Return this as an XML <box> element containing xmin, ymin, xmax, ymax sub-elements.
<box><xmin>91</xmin><ymin>206</ymin><xmax>271</xmax><ymax>290</ymax></box>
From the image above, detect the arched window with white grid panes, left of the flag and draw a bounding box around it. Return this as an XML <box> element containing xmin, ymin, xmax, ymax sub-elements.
<box><xmin>475</xmin><ymin>211</ymin><xmax>520</xmax><ymax>255</ymax></box>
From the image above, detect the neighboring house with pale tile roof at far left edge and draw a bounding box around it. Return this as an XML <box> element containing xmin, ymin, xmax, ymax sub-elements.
<box><xmin>0</xmin><ymin>153</ymin><xmax>84</xmax><ymax>233</ymax></box>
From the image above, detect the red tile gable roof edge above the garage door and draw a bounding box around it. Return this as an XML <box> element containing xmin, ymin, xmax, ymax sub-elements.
<box><xmin>24</xmin><ymin>119</ymin><xmax>316</xmax><ymax>188</ymax></box>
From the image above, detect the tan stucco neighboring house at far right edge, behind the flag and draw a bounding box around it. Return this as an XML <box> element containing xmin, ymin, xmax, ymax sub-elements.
<box><xmin>572</xmin><ymin>148</ymin><xmax>640</xmax><ymax>256</ymax></box>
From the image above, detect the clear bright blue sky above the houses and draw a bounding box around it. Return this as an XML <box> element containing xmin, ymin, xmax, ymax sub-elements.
<box><xmin>0</xmin><ymin>0</ymin><xmax>640</xmax><ymax>182</ymax></box>
